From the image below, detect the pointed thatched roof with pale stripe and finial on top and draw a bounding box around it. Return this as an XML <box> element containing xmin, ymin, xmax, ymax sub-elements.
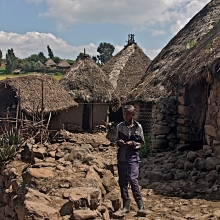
<box><xmin>102</xmin><ymin>43</ymin><xmax>151</xmax><ymax>97</ymax></box>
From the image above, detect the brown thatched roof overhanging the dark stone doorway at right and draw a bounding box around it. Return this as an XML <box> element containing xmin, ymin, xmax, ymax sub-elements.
<box><xmin>166</xmin><ymin>22</ymin><xmax>220</xmax><ymax>88</ymax></box>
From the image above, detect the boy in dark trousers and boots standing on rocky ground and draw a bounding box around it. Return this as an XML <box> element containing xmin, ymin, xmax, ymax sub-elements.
<box><xmin>116</xmin><ymin>105</ymin><xmax>146</xmax><ymax>217</ymax></box>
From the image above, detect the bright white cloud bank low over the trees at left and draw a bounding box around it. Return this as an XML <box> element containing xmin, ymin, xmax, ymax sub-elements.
<box><xmin>0</xmin><ymin>31</ymin><xmax>97</xmax><ymax>59</ymax></box>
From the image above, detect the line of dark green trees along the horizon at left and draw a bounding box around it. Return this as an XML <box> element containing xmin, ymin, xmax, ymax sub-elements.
<box><xmin>0</xmin><ymin>42</ymin><xmax>115</xmax><ymax>73</ymax></box>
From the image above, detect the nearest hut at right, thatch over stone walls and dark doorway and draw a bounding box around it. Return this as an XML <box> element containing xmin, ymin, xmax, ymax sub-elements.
<box><xmin>164</xmin><ymin>22</ymin><xmax>220</xmax><ymax>155</ymax></box>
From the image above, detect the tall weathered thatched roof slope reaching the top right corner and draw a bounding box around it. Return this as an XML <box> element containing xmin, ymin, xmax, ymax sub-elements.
<box><xmin>128</xmin><ymin>0</ymin><xmax>220</xmax><ymax>101</ymax></box>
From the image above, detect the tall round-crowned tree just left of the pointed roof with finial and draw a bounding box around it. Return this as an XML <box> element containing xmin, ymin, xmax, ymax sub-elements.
<box><xmin>97</xmin><ymin>42</ymin><xmax>115</xmax><ymax>65</ymax></box>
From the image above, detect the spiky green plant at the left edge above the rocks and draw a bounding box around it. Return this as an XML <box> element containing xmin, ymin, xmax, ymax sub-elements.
<box><xmin>0</xmin><ymin>129</ymin><xmax>22</xmax><ymax>162</ymax></box>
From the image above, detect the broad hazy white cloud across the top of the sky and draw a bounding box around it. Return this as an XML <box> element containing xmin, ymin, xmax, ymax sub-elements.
<box><xmin>26</xmin><ymin>0</ymin><xmax>210</xmax><ymax>33</ymax></box>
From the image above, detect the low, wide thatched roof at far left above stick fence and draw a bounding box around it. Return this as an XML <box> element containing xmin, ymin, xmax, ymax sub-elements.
<box><xmin>0</xmin><ymin>74</ymin><xmax>78</xmax><ymax>114</ymax></box>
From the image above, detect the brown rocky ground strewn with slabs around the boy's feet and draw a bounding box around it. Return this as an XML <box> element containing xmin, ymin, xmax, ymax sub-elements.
<box><xmin>0</xmin><ymin>132</ymin><xmax>220</xmax><ymax>220</ymax></box>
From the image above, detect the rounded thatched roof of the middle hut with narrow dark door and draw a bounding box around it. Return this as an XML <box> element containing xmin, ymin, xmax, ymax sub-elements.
<box><xmin>60</xmin><ymin>56</ymin><xmax>115</xmax><ymax>102</ymax></box>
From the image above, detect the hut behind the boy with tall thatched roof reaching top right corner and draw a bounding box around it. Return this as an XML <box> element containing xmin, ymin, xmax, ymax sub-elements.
<box><xmin>126</xmin><ymin>0</ymin><xmax>220</xmax><ymax>134</ymax></box>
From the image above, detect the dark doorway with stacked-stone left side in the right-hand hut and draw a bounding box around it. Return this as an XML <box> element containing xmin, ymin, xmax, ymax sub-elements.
<box><xmin>177</xmin><ymin>82</ymin><xmax>207</xmax><ymax>148</ymax></box>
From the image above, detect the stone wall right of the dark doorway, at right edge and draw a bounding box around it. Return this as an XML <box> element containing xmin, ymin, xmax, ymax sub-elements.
<box><xmin>204</xmin><ymin>79</ymin><xmax>220</xmax><ymax>155</ymax></box>
